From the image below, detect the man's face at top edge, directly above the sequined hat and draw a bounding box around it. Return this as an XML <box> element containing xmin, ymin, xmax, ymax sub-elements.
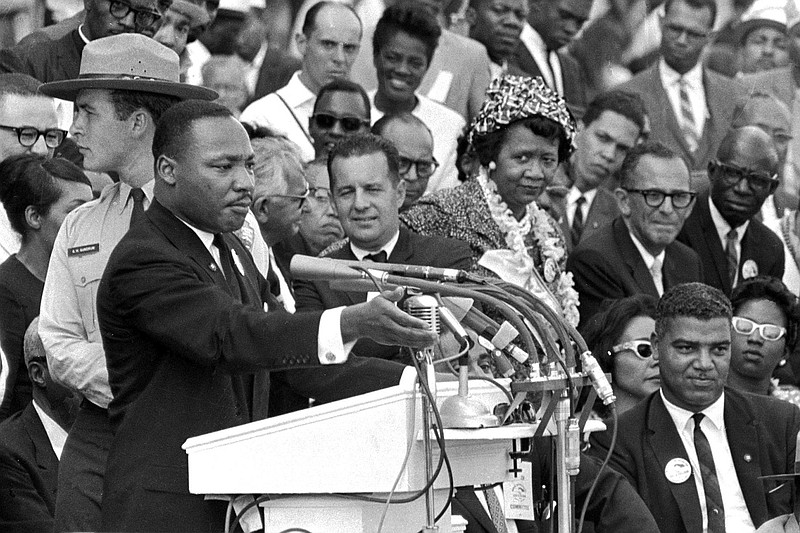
<box><xmin>468</xmin><ymin>0</ymin><xmax>528</xmax><ymax>64</ymax></box>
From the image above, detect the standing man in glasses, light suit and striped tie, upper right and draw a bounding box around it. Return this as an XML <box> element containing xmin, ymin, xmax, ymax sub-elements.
<box><xmin>618</xmin><ymin>0</ymin><xmax>747</xmax><ymax>170</ymax></box>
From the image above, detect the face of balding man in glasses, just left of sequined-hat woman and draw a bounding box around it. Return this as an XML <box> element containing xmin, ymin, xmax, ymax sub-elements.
<box><xmin>383</xmin><ymin>120</ymin><xmax>435</xmax><ymax>209</ymax></box>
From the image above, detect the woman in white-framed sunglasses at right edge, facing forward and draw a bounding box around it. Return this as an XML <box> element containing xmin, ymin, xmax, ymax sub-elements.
<box><xmin>728</xmin><ymin>276</ymin><xmax>800</xmax><ymax>405</ymax></box>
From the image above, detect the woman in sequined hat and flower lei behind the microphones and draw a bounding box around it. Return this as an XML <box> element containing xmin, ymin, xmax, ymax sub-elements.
<box><xmin>401</xmin><ymin>75</ymin><xmax>578</xmax><ymax>325</ymax></box>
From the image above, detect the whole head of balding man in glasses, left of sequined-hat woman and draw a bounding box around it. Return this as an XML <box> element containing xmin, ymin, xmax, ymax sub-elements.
<box><xmin>372</xmin><ymin>113</ymin><xmax>439</xmax><ymax>212</ymax></box>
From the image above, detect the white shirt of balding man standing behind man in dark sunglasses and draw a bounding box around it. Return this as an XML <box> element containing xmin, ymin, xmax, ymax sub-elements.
<box><xmin>239</xmin><ymin>70</ymin><xmax>317</xmax><ymax>162</ymax></box>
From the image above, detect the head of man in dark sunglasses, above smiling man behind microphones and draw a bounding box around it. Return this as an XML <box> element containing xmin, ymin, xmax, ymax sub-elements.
<box><xmin>308</xmin><ymin>78</ymin><xmax>370</xmax><ymax>157</ymax></box>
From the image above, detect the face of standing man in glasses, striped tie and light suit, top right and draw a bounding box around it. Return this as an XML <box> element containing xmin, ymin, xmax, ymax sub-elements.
<box><xmin>661</xmin><ymin>0</ymin><xmax>711</xmax><ymax>74</ymax></box>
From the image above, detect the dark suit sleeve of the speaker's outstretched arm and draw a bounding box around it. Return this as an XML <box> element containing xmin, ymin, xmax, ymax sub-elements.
<box><xmin>97</xmin><ymin>241</ymin><xmax>321</xmax><ymax>371</ymax></box>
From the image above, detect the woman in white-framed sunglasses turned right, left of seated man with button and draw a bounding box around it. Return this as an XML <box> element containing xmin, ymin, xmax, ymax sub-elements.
<box><xmin>582</xmin><ymin>294</ymin><xmax>661</xmax><ymax>416</ymax></box>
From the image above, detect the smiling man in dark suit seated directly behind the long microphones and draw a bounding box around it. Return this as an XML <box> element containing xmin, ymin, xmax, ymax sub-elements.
<box><xmin>295</xmin><ymin>134</ymin><xmax>472</xmax><ymax>362</ymax></box>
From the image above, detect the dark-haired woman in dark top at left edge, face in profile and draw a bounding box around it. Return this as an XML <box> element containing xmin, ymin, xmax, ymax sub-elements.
<box><xmin>0</xmin><ymin>154</ymin><xmax>92</xmax><ymax>420</ymax></box>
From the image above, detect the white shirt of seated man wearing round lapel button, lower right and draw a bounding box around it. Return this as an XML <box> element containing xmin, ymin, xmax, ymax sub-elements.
<box><xmin>659</xmin><ymin>390</ymin><xmax>756</xmax><ymax>533</ymax></box>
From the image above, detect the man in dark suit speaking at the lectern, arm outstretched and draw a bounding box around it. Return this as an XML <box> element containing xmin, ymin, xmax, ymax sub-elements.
<box><xmin>97</xmin><ymin>101</ymin><xmax>436</xmax><ymax>531</ymax></box>
